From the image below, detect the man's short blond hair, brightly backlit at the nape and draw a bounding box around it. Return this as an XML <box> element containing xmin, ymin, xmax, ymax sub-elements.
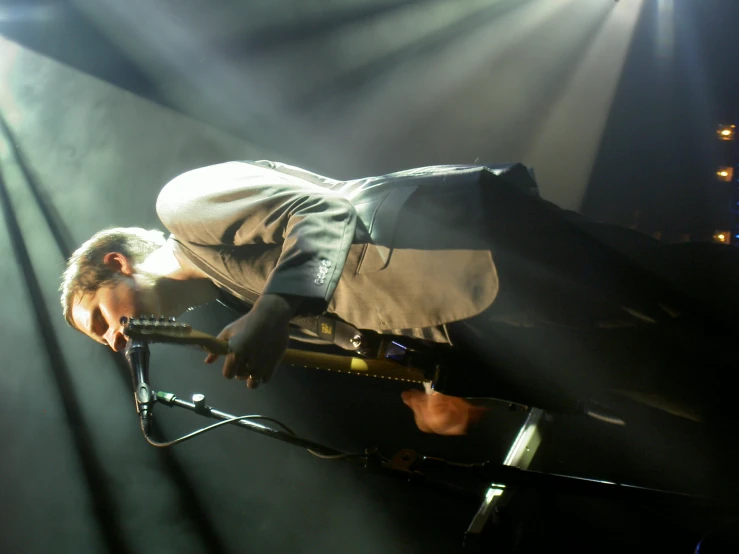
<box><xmin>59</xmin><ymin>227</ymin><xmax>166</xmax><ymax>329</ymax></box>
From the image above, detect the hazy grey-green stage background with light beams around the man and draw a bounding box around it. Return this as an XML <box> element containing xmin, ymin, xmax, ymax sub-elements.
<box><xmin>0</xmin><ymin>0</ymin><xmax>739</xmax><ymax>553</ymax></box>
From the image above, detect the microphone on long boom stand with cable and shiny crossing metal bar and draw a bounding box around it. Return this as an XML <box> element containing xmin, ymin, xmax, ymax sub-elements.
<box><xmin>127</xmin><ymin>340</ymin><xmax>737</xmax><ymax>552</ymax></box>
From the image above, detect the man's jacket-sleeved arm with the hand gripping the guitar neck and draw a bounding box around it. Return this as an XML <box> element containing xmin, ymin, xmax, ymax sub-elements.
<box><xmin>157</xmin><ymin>162</ymin><xmax>356</xmax><ymax>388</ymax></box>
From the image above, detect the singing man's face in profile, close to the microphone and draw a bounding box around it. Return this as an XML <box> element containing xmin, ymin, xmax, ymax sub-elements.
<box><xmin>72</xmin><ymin>276</ymin><xmax>143</xmax><ymax>352</ymax></box>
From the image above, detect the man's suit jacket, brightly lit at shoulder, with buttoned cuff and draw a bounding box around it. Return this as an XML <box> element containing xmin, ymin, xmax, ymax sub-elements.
<box><xmin>157</xmin><ymin>161</ymin><xmax>535</xmax><ymax>330</ymax></box>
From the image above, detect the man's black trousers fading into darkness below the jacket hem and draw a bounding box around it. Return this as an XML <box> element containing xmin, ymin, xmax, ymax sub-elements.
<box><xmin>442</xmin><ymin>168</ymin><xmax>739</xmax><ymax>425</ymax></box>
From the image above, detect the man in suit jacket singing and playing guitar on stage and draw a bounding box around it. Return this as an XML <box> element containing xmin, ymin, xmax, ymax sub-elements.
<box><xmin>62</xmin><ymin>161</ymin><xmax>736</xmax><ymax>434</ymax></box>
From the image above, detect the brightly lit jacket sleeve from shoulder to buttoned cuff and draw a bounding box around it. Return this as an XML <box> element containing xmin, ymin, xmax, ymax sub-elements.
<box><xmin>157</xmin><ymin>162</ymin><xmax>356</xmax><ymax>311</ymax></box>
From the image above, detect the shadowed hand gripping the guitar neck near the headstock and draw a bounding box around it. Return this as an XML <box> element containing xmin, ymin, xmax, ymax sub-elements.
<box><xmin>205</xmin><ymin>294</ymin><xmax>300</xmax><ymax>389</ymax></box>
